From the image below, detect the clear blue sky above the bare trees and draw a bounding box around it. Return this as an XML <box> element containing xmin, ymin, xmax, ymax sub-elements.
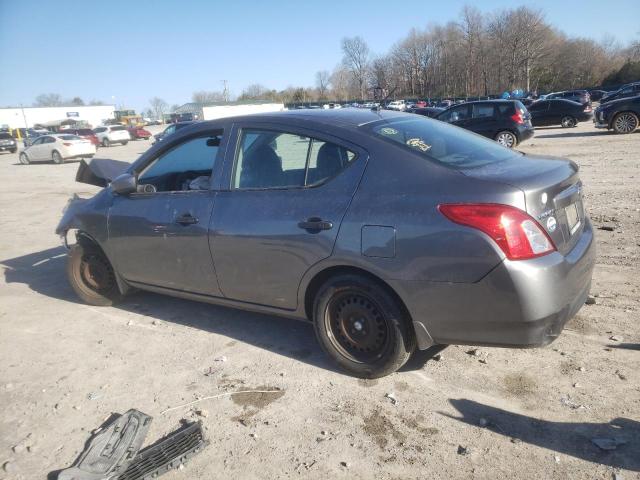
<box><xmin>0</xmin><ymin>0</ymin><xmax>640</xmax><ymax>111</ymax></box>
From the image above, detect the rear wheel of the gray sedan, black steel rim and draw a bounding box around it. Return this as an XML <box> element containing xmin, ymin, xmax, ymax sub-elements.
<box><xmin>313</xmin><ymin>275</ymin><xmax>416</xmax><ymax>378</ymax></box>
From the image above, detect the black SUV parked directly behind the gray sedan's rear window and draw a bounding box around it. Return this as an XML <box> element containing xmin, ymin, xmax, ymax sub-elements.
<box><xmin>435</xmin><ymin>100</ymin><xmax>534</xmax><ymax>148</ymax></box>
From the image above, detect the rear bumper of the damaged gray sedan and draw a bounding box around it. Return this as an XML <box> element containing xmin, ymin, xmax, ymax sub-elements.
<box><xmin>392</xmin><ymin>221</ymin><xmax>595</xmax><ymax>349</ymax></box>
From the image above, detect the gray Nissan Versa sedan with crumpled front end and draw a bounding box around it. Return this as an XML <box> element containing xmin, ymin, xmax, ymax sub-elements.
<box><xmin>57</xmin><ymin>109</ymin><xmax>595</xmax><ymax>377</ymax></box>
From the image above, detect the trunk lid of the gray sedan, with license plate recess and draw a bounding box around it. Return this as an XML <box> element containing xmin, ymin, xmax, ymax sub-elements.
<box><xmin>461</xmin><ymin>154</ymin><xmax>585</xmax><ymax>254</ymax></box>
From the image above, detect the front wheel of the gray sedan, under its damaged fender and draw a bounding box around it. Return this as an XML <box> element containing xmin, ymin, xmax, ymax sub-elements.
<box><xmin>67</xmin><ymin>241</ymin><xmax>123</xmax><ymax>307</ymax></box>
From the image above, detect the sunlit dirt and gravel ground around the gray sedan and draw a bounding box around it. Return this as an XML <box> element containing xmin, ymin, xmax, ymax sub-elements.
<box><xmin>0</xmin><ymin>123</ymin><xmax>640</xmax><ymax>480</ymax></box>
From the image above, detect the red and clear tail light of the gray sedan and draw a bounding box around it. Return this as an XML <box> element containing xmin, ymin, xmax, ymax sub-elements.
<box><xmin>438</xmin><ymin>203</ymin><xmax>556</xmax><ymax>260</ymax></box>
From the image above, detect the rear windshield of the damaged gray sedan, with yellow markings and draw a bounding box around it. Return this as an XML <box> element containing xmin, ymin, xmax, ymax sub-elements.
<box><xmin>368</xmin><ymin>117</ymin><xmax>521</xmax><ymax>169</ymax></box>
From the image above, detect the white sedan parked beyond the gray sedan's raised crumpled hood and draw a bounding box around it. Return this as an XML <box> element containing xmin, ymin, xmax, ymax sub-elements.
<box><xmin>20</xmin><ymin>134</ymin><xmax>96</xmax><ymax>165</ymax></box>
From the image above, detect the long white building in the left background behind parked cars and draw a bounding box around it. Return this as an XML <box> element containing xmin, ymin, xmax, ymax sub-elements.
<box><xmin>0</xmin><ymin>105</ymin><xmax>115</xmax><ymax>128</ymax></box>
